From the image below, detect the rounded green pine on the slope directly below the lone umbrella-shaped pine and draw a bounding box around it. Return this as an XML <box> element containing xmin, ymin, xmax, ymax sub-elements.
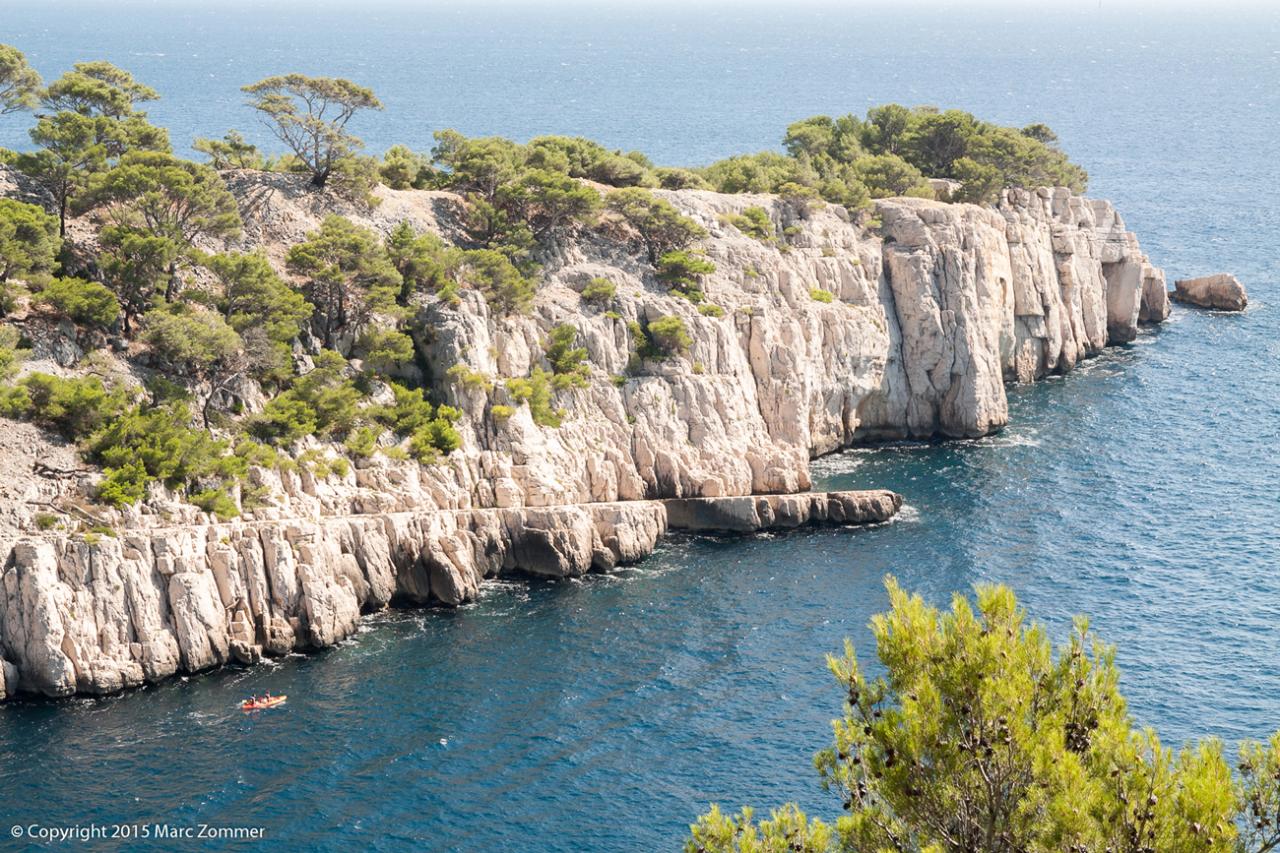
<box><xmin>285</xmin><ymin>215</ymin><xmax>403</xmax><ymax>347</ymax></box>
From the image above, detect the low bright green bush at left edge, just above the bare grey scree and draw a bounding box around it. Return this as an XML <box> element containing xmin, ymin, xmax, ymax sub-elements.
<box><xmin>0</xmin><ymin>373</ymin><xmax>129</xmax><ymax>441</ymax></box>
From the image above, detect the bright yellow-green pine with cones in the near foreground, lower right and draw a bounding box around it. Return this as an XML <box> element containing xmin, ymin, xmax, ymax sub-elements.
<box><xmin>685</xmin><ymin>578</ymin><xmax>1280</xmax><ymax>853</ymax></box>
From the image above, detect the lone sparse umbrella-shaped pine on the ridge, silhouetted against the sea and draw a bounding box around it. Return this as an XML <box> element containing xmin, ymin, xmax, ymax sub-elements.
<box><xmin>243</xmin><ymin>74</ymin><xmax>383</xmax><ymax>190</ymax></box>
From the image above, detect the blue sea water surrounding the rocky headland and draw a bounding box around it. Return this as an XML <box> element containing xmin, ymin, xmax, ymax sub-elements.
<box><xmin>0</xmin><ymin>0</ymin><xmax>1280</xmax><ymax>852</ymax></box>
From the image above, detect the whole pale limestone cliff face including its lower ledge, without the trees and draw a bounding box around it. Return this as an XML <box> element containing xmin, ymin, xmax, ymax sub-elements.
<box><xmin>0</xmin><ymin>173</ymin><xmax>1169</xmax><ymax>695</ymax></box>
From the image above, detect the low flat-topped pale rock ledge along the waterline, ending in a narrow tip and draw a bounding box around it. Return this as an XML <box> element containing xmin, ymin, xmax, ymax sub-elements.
<box><xmin>0</xmin><ymin>491</ymin><xmax>902</xmax><ymax>699</ymax></box>
